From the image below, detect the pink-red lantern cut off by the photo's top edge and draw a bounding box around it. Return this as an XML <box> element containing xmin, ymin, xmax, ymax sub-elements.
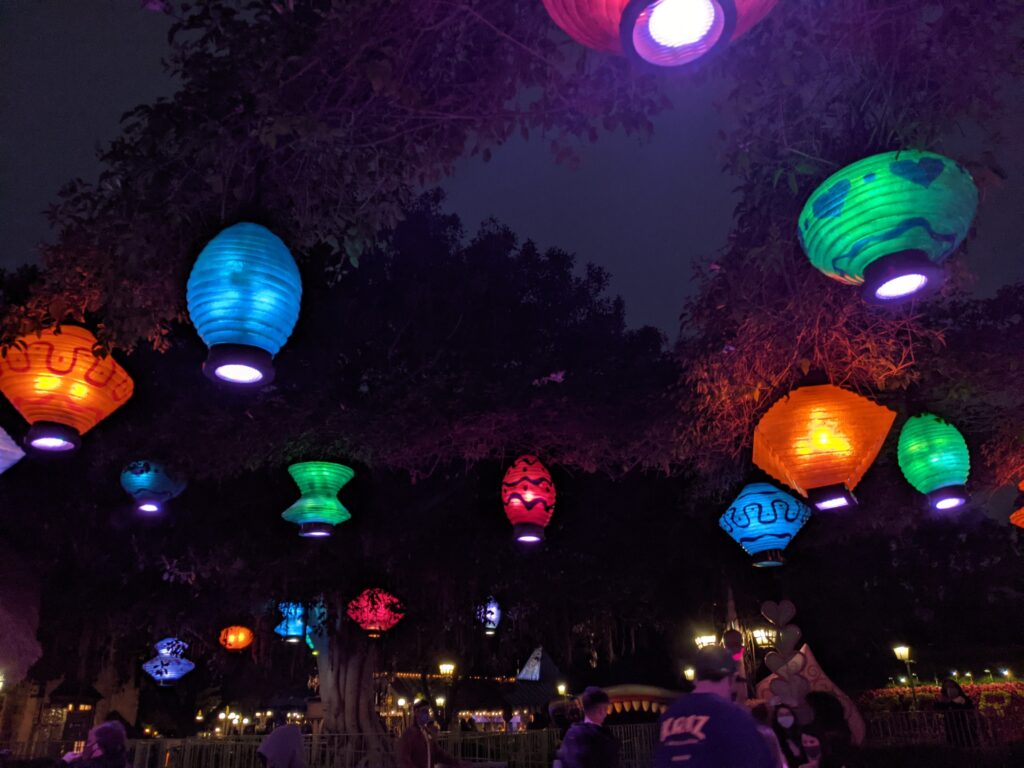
<box><xmin>544</xmin><ymin>0</ymin><xmax>778</xmax><ymax>67</ymax></box>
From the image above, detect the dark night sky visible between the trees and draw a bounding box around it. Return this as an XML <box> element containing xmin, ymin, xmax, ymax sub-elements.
<box><xmin>0</xmin><ymin>0</ymin><xmax>1024</xmax><ymax>337</ymax></box>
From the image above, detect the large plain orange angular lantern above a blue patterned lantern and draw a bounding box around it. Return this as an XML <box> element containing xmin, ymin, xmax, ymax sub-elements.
<box><xmin>754</xmin><ymin>384</ymin><xmax>896</xmax><ymax>510</ymax></box>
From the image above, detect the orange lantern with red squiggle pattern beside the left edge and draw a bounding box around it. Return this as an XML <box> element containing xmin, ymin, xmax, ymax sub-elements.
<box><xmin>0</xmin><ymin>326</ymin><xmax>134</xmax><ymax>451</ymax></box>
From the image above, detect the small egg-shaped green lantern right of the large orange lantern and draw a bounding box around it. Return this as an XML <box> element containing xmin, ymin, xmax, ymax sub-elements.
<box><xmin>896</xmin><ymin>414</ymin><xmax>971</xmax><ymax>510</ymax></box>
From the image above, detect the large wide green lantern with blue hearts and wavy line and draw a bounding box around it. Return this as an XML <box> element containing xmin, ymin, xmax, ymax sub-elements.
<box><xmin>799</xmin><ymin>151</ymin><xmax>978</xmax><ymax>303</ymax></box>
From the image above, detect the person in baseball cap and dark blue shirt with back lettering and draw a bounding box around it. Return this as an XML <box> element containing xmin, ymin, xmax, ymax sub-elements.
<box><xmin>654</xmin><ymin>645</ymin><xmax>777</xmax><ymax>768</ymax></box>
